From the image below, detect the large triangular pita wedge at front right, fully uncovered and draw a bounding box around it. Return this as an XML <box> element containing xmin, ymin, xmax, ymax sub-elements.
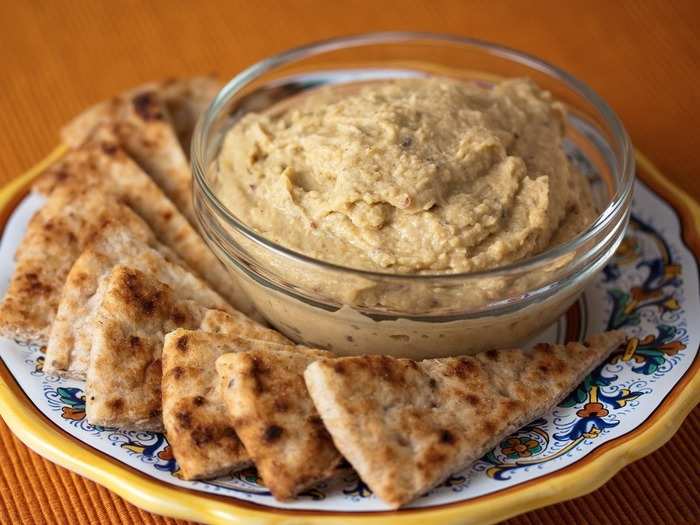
<box><xmin>305</xmin><ymin>332</ymin><xmax>624</xmax><ymax>507</ymax></box>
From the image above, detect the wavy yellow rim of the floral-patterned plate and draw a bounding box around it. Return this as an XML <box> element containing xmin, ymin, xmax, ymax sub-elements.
<box><xmin>0</xmin><ymin>146</ymin><xmax>700</xmax><ymax>525</ymax></box>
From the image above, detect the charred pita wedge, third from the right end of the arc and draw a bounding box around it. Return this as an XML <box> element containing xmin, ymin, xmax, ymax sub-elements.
<box><xmin>162</xmin><ymin>328</ymin><xmax>293</xmax><ymax>479</ymax></box>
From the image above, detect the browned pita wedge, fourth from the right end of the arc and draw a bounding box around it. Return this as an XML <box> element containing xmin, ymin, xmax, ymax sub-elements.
<box><xmin>86</xmin><ymin>266</ymin><xmax>288</xmax><ymax>431</ymax></box>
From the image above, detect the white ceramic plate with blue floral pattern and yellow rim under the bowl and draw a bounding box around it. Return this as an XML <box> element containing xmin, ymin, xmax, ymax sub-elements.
<box><xmin>0</xmin><ymin>151</ymin><xmax>700</xmax><ymax>524</ymax></box>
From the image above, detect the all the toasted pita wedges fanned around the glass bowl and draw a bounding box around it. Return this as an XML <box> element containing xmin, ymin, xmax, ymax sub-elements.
<box><xmin>0</xmin><ymin>78</ymin><xmax>624</xmax><ymax>508</ymax></box>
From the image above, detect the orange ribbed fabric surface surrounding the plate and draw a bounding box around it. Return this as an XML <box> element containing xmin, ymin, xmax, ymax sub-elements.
<box><xmin>0</xmin><ymin>0</ymin><xmax>700</xmax><ymax>525</ymax></box>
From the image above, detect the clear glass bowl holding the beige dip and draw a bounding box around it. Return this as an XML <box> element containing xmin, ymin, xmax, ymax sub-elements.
<box><xmin>191</xmin><ymin>33</ymin><xmax>634</xmax><ymax>358</ymax></box>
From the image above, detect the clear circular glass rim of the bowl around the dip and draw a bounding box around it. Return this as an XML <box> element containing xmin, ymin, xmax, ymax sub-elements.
<box><xmin>190</xmin><ymin>31</ymin><xmax>635</xmax><ymax>282</ymax></box>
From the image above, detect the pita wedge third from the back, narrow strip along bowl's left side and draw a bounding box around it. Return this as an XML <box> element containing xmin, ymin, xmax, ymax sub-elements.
<box><xmin>35</xmin><ymin>134</ymin><xmax>255</xmax><ymax>315</ymax></box>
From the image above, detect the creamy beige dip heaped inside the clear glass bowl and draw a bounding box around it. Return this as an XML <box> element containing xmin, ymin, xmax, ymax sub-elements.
<box><xmin>214</xmin><ymin>78</ymin><xmax>597</xmax><ymax>274</ymax></box>
